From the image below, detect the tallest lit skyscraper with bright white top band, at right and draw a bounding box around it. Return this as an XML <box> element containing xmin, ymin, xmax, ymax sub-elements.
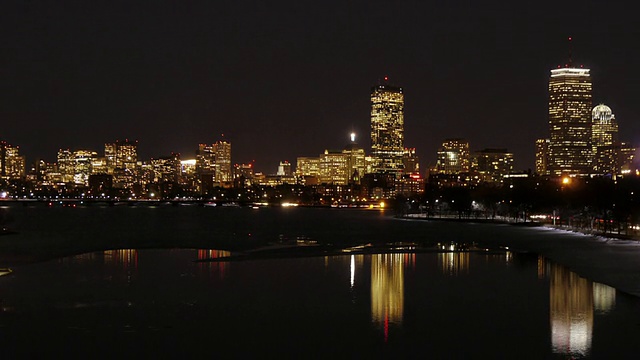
<box><xmin>548</xmin><ymin>63</ymin><xmax>593</xmax><ymax>175</ymax></box>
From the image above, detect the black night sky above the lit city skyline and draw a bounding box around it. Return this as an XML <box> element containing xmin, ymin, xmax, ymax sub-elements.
<box><xmin>0</xmin><ymin>0</ymin><xmax>640</xmax><ymax>173</ymax></box>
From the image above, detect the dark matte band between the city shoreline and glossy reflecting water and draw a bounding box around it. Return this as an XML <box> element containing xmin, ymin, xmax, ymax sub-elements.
<box><xmin>0</xmin><ymin>206</ymin><xmax>640</xmax><ymax>296</ymax></box>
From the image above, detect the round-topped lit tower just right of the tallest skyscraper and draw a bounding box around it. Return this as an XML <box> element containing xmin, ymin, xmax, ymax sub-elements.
<box><xmin>591</xmin><ymin>104</ymin><xmax>620</xmax><ymax>174</ymax></box>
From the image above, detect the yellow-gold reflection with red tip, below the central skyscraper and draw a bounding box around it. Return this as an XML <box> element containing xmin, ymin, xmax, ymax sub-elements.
<box><xmin>371</xmin><ymin>254</ymin><xmax>404</xmax><ymax>338</ymax></box>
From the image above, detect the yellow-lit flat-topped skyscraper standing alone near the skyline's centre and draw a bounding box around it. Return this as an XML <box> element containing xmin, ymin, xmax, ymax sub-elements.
<box><xmin>371</xmin><ymin>78</ymin><xmax>404</xmax><ymax>177</ymax></box>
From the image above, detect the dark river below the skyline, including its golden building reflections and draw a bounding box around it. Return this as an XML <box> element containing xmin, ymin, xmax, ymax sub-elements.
<box><xmin>0</xmin><ymin>204</ymin><xmax>640</xmax><ymax>359</ymax></box>
